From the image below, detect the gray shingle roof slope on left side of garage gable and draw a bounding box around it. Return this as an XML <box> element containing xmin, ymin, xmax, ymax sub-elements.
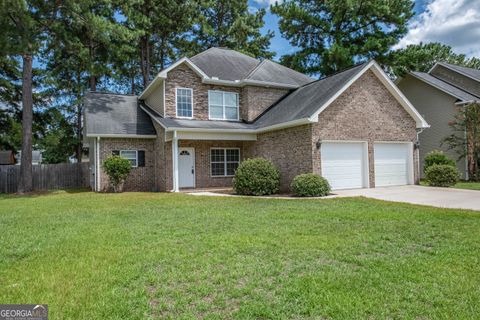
<box><xmin>254</xmin><ymin>63</ymin><xmax>367</xmax><ymax>128</ymax></box>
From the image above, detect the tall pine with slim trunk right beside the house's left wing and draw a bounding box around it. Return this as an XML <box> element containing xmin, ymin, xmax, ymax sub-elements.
<box><xmin>44</xmin><ymin>0</ymin><xmax>135</xmax><ymax>161</ymax></box>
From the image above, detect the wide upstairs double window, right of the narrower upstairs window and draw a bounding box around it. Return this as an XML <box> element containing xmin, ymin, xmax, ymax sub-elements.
<box><xmin>208</xmin><ymin>90</ymin><xmax>239</xmax><ymax>120</ymax></box>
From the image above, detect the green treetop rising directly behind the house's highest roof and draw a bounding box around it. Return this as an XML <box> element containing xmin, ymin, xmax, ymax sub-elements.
<box><xmin>187</xmin><ymin>0</ymin><xmax>275</xmax><ymax>58</ymax></box>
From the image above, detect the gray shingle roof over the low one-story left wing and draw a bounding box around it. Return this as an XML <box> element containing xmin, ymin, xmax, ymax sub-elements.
<box><xmin>85</xmin><ymin>92</ymin><xmax>156</xmax><ymax>136</ymax></box>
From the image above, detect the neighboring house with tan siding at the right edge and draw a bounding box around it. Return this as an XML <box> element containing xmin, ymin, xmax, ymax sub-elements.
<box><xmin>397</xmin><ymin>63</ymin><xmax>480</xmax><ymax>179</ymax></box>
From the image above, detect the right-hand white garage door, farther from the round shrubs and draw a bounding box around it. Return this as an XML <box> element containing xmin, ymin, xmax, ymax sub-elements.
<box><xmin>374</xmin><ymin>143</ymin><xmax>412</xmax><ymax>187</ymax></box>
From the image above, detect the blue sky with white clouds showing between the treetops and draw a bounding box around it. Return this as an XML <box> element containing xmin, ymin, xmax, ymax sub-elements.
<box><xmin>249</xmin><ymin>0</ymin><xmax>480</xmax><ymax>60</ymax></box>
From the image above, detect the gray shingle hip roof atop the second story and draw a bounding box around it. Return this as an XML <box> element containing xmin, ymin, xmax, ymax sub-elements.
<box><xmin>190</xmin><ymin>48</ymin><xmax>314</xmax><ymax>86</ymax></box>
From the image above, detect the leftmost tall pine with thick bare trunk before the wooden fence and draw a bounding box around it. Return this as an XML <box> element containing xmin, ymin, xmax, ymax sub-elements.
<box><xmin>0</xmin><ymin>0</ymin><xmax>52</xmax><ymax>193</ymax></box>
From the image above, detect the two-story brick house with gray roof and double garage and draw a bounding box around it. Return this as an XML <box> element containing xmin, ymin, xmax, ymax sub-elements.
<box><xmin>85</xmin><ymin>48</ymin><xmax>428</xmax><ymax>191</ymax></box>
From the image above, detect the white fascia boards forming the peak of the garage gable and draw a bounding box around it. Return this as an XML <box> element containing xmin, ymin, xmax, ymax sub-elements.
<box><xmin>310</xmin><ymin>60</ymin><xmax>430</xmax><ymax>128</ymax></box>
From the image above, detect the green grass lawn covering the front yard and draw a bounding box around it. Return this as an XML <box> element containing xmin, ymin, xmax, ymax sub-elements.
<box><xmin>0</xmin><ymin>192</ymin><xmax>480</xmax><ymax>319</ymax></box>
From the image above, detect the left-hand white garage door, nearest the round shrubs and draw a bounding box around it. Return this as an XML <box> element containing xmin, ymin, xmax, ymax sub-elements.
<box><xmin>321</xmin><ymin>142</ymin><xmax>366</xmax><ymax>189</ymax></box>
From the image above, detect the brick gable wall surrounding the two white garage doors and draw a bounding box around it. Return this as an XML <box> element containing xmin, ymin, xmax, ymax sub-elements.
<box><xmin>312</xmin><ymin>71</ymin><xmax>418</xmax><ymax>187</ymax></box>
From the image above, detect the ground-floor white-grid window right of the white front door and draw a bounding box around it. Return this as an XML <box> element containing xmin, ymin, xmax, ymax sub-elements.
<box><xmin>210</xmin><ymin>148</ymin><xmax>240</xmax><ymax>177</ymax></box>
